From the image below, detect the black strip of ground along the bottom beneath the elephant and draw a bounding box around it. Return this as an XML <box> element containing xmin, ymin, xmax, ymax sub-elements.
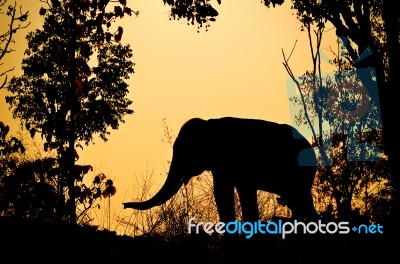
<box><xmin>0</xmin><ymin>219</ymin><xmax>397</xmax><ymax>264</ymax></box>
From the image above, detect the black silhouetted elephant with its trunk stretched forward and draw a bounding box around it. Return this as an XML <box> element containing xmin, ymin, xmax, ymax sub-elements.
<box><xmin>123</xmin><ymin>117</ymin><xmax>317</xmax><ymax>223</ymax></box>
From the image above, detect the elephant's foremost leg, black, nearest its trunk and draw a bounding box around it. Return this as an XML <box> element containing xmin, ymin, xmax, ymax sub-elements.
<box><xmin>213</xmin><ymin>172</ymin><xmax>236</xmax><ymax>223</ymax></box>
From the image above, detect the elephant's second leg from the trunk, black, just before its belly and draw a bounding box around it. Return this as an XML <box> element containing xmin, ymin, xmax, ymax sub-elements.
<box><xmin>237</xmin><ymin>186</ymin><xmax>259</xmax><ymax>222</ymax></box>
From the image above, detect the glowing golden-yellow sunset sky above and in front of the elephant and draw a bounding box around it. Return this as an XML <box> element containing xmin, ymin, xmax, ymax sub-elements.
<box><xmin>0</xmin><ymin>0</ymin><xmax>334</xmax><ymax>231</ymax></box>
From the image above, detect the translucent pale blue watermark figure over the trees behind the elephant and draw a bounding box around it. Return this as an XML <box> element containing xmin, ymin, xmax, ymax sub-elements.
<box><xmin>286</xmin><ymin>37</ymin><xmax>383</xmax><ymax>166</ymax></box>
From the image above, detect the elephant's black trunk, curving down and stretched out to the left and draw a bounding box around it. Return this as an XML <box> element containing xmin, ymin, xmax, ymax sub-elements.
<box><xmin>123</xmin><ymin>162</ymin><xmax>183</xmax><ymax>210</ymax></box>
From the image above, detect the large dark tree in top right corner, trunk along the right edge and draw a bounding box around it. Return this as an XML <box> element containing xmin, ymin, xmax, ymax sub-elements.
<box><xmin>292</xmin><ymin>0</ymin><xmax>400</xmax><ymax>217</ymax></box>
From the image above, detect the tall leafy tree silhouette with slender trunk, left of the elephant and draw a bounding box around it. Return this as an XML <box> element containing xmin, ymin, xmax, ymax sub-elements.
<box><xmin>6</xmin><ymin>0</ymin><xmax>134</xmax><ymax>224</ymax></box>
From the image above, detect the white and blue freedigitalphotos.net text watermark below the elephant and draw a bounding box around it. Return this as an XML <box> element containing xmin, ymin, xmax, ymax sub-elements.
<box><xmin>188</xmin><ymin>217</ymin><xmax>383</xmax><ymax>239</ymax></box>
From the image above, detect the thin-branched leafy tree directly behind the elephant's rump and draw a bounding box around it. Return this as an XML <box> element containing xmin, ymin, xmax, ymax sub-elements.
<box><xmin>283</xmin><ymin>23</ymin><xmax>393</xmax><ymax>221</ymax></box>
